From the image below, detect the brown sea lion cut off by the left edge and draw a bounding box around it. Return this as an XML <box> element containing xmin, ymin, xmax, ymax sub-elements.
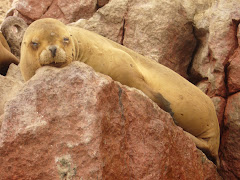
<box><xmin>0</xmin><ymin>32</ymin><xmax>19</xmax><ymax>76</ymax></box>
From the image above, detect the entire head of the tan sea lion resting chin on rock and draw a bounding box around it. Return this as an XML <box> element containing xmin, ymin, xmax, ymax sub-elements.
<box><xmin>20</xmin><ymin>18</ymin><xmax>74</xmax><ymax>80</ymax></box>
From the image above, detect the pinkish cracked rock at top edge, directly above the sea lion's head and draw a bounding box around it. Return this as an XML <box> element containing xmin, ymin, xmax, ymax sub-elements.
<box><xmin>13</xmin><ymin>0</ymin><xmax>97</xmax><ymax>24</ymax></box>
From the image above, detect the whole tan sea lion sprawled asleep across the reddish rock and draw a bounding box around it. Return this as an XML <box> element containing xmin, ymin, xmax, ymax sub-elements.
<box><xmin>20</xmin><ymin>18</ymin><xmax>220</xmax><ymax>166</ymax></box>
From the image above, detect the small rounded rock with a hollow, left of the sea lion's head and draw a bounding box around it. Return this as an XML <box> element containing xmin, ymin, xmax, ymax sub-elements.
<box><xmin>1</xmin><ymin>16</ymin><xmax>27</xmax><ymax>58</ymax></box>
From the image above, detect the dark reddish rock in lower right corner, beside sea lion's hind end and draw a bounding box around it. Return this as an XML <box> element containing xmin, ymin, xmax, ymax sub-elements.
<box><xmin>220</xmin><ymin>93</ymin><xmax>240</xmax><ymax>180</ymax></box>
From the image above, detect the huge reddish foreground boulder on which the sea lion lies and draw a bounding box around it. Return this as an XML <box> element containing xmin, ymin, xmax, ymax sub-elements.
<box><xmin>0</xmin><ymin>62</ymin><xmax>220</xmax><ymax>180</ymax></box>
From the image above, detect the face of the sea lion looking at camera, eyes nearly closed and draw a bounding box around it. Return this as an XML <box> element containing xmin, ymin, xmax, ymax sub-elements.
<box><xmin>23</xmin><ymin>18</ymin><xmax>74</xmax><ymax>67</ymax></box>
